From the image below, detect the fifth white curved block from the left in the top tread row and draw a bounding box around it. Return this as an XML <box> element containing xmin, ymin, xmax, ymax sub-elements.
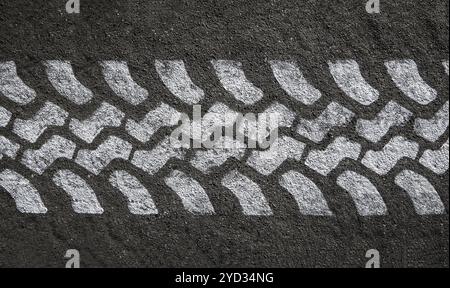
<box><xmin>211</xmin><ymin>60</ymin><xmax>263</xmax><ymax>105</ymax></box>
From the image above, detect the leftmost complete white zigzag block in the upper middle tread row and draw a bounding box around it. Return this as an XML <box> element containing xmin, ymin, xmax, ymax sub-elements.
<box><xmin>13</xmin><ymin>102</ymin><xmax>69</xmax><ymax>143</ymax></box>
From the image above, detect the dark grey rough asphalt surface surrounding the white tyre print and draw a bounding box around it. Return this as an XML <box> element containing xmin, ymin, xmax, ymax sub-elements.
<box><xmin>0</xmin><ymin>0</ymin><xmax>449</xmax><ymax>267</ymax></box>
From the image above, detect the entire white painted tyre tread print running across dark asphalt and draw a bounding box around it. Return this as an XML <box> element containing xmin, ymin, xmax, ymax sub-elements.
<box><xmin>0</xmin><ymin>59</ymin><xmax>449</xmax><ymax>217</ymax></box>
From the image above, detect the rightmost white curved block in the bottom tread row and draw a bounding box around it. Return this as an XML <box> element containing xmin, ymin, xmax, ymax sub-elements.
<box><xmin>395</xmin><ymin>170</ymin><xmax>445</xmax><ymax>215</ymax></box>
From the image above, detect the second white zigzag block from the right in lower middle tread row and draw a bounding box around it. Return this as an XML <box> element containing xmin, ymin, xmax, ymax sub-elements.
<box><xmin>361</xmin><ymin>136</ymin><xmax>419</xmax><ymax>175</ymax></box>
